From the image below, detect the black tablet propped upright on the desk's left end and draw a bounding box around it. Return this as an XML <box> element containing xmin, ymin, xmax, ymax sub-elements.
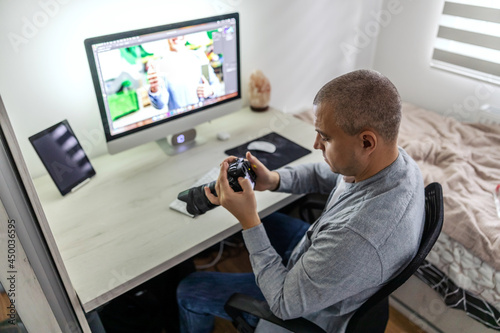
<box><xmin>29</xmin><ymin>120</ymin><xmax>95</xmax><ymax>195</ymax></box>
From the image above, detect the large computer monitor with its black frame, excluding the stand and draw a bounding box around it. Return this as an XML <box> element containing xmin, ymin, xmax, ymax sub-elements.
<box><xmin>85</xmin><ymin>13</ymin><xmax>241</xmax><ymax>153</ymax></box>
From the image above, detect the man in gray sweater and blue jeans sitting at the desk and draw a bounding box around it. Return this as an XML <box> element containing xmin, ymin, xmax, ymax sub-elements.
<box><xmin>178</xmin><ymin>70</ymin><xmax>425</xmax><ymax>332</ymax></box>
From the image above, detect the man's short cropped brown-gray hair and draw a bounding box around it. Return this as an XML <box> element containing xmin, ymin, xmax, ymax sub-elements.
<box><xmin>313</xmin><ymin>69</ymin><xmax>401</xmax><ymax>142</ymax></box>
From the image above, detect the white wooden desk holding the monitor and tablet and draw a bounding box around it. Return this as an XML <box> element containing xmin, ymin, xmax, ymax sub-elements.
<box><xmin>33</xmin><ymin>109</ymin><xmax>323</xmax><ymax>312</ymax></box>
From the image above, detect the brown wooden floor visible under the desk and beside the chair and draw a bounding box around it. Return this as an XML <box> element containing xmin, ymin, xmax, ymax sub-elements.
<box><xmin>195</xmin><ymin>233</ymin><xmax>425</xmax><ymax>333</ymax></box>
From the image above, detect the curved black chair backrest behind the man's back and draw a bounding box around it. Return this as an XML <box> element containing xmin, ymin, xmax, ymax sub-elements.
<box><xmin>346</xmin><ymin>183</ymin><xmax>444</xmax><ymax>332</ymax></box>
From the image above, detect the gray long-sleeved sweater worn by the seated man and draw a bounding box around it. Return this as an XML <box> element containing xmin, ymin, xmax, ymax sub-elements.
<box><xmin>243</xmin><ymin>148</ymin><xmax>425</xmax><ymax>332</ymax></box>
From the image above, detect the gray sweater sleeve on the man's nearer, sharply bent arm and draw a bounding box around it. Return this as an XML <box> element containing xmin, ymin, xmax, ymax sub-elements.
<box><xmin>243</xmin><ymin>225</ymin><xmax>382</xmax><ymax>319</ymax></box>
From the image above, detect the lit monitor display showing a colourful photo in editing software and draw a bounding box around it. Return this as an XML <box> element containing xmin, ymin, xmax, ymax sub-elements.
<box><xmin>92</xmin><ymin>18</ymin><xmax>238</xmax><ymax>137</ymax></box>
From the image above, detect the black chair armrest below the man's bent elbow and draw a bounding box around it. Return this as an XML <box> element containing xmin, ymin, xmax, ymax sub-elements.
<box><xmin>224</xmin><ymin>293</ymin><xmax>325</xmax><ymax>333</ymax></box>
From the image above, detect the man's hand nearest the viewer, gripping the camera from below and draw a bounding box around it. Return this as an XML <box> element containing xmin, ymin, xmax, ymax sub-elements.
<box><xmin>205</xmin><ymin>156</ymin><xmax>261</xmax><ymax>229</ymax></box>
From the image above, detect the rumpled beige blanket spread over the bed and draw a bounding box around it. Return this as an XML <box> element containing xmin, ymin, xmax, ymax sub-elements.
<box><xmin>292</xmin><ymin>103</ymin><xmax>500</xmax><ymax>271</ymax></box>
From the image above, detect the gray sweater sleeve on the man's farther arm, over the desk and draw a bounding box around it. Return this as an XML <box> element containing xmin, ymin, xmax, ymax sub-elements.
<box><xmin>276</xmin><ymin>162</ymin><xmax>339</xmax><ymax>194</ymax></box>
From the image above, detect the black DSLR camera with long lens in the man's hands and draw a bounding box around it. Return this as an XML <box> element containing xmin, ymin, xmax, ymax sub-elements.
<box><xmin>177</xmin><ymin>158</ymin><xmax>257</xmax><ymax>216</ymax></box>
